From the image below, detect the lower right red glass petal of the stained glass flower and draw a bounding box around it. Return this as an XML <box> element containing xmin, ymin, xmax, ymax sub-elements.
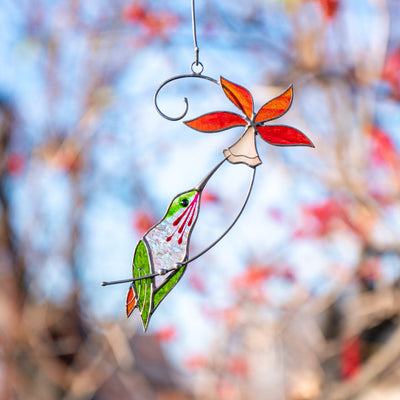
<box><xmin>257</xmin><ymin>125</ymin><xmax>314</xmax><ymax>147</ymax></box>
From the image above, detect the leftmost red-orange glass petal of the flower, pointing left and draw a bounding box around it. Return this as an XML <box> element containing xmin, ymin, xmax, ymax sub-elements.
<box><xmin>185</xmin><ymin>112</ymin><xmax>247</xmax><ymax>132</ymax></box>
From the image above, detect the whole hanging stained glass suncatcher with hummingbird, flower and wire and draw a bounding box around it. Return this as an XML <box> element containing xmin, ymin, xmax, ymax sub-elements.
<box><xmin>103</xmin><ymin>0</ymin><xmax>314</xmax><ymax>331</ymax></box>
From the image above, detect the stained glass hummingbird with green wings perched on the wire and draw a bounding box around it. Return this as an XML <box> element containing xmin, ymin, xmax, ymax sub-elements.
<box><xmin>102</xmin><ymin>159</ymin><xmax>225</xmax><ymax>331</ymax></box>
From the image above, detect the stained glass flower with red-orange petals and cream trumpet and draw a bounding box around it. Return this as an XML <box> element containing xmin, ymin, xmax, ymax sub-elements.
<box><xmin>185</xmin><ymin>76</ymin><xmax>314</xmax><ymax>167</ymax></box>
